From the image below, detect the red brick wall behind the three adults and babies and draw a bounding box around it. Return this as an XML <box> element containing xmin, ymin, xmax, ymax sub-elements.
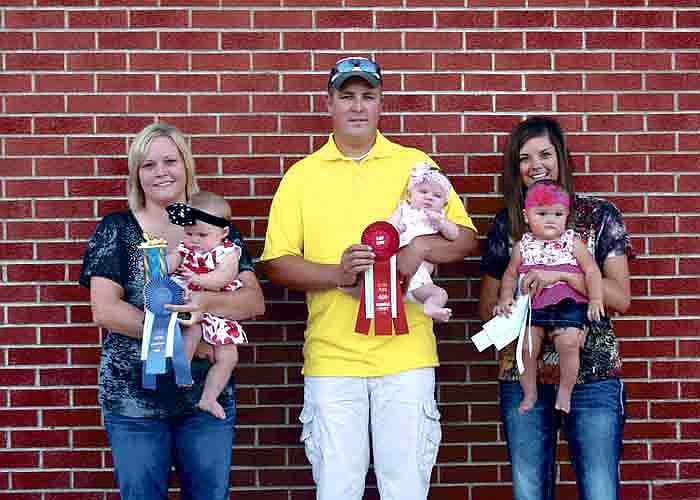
<box><xmin>0</xmin><ymin>0</ymin><xmax>700</xmax><ymax>500</ymax></box>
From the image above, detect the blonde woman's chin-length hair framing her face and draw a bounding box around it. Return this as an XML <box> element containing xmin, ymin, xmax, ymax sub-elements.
<box><xmin>126</xmin><ymin>122</ymin><xmax>199</xmax><ymax>211</ymax></box>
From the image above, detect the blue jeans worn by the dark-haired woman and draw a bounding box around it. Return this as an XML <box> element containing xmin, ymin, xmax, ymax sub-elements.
<box><xmin>500</xmin><ymin>379</ymin><xmax>625</xmax><ymax>500</ymax></box>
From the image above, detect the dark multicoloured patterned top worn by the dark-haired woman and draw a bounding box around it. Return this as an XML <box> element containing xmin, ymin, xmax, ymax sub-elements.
<box><xmin>481</xmin><ymin>195</ymin><xmax>633</xmax><ymax>384</ymax></box>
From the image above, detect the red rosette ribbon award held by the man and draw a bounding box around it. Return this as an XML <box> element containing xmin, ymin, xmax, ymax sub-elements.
<box><xmin>355</xmin><ymin>221</ymin><xmax>408</xmax><ymax>335</ymax></box>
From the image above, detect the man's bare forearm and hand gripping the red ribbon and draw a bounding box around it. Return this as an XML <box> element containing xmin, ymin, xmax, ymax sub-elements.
<box><xmin>260</xmin><ymin>245</ymin><xmax>374</xmax><ymax>291</ymax></box>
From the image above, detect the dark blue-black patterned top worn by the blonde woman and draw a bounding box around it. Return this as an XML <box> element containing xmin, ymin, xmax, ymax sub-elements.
<box><xmin>80</xmin><ymin>210</ymin><xmax>254</xmax><ymax>418</ymax></box>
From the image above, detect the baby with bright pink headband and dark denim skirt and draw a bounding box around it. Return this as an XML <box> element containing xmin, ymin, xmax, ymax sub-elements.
<box><xmin>494</xmin><ymin>181</ymin><xmax>604</xmax><ymax>413</ymax></box>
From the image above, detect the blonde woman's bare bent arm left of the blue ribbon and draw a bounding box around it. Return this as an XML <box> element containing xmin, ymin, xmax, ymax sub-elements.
<box><xmin>90</xmin><ymin>276</ymin><xmax>144</xmax><ymax>339</ymax></box>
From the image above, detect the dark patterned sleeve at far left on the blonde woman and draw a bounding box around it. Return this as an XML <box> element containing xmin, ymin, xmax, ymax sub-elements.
<box><xmin>78</xmin><ymin>214</ymin><xmax>124</xmax><ymax>288</ymax></box>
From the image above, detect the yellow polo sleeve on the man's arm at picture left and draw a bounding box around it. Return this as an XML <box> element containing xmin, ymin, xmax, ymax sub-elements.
<box><xmin>260</xmin><ymin>166</ymin><xmax>304</xmax><ymax>261</ymax></box>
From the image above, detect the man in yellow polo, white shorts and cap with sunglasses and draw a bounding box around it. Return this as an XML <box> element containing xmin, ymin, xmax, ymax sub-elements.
<box><xmin>261</xmin><ymin>57</ymin><xmax>476</xmax><ymax>500</ymax></box>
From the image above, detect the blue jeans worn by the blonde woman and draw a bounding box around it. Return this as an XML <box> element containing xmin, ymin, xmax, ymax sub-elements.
<box><xmin>104</xmin><ymin>404</ymin><xmax>236</xmax><ymax>500</ymax></box>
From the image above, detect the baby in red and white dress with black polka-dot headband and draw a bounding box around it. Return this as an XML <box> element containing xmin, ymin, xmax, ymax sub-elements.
<box><xmin>168</xmin><ymin>191</ymin><xmax>248</xmax><ymax>419</ymax></box>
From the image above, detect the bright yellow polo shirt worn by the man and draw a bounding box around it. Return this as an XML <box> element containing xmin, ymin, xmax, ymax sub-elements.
<box><xmin>261</xmin><ymin>133</ymin><xmax>476</xmax><ymax>377</ymax></box>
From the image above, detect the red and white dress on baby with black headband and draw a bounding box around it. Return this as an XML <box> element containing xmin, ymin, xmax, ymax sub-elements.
<box><xmin>172</xmin><ymin>240</ymin><xmax>248</xmax><ymax>345</ymax></box>
